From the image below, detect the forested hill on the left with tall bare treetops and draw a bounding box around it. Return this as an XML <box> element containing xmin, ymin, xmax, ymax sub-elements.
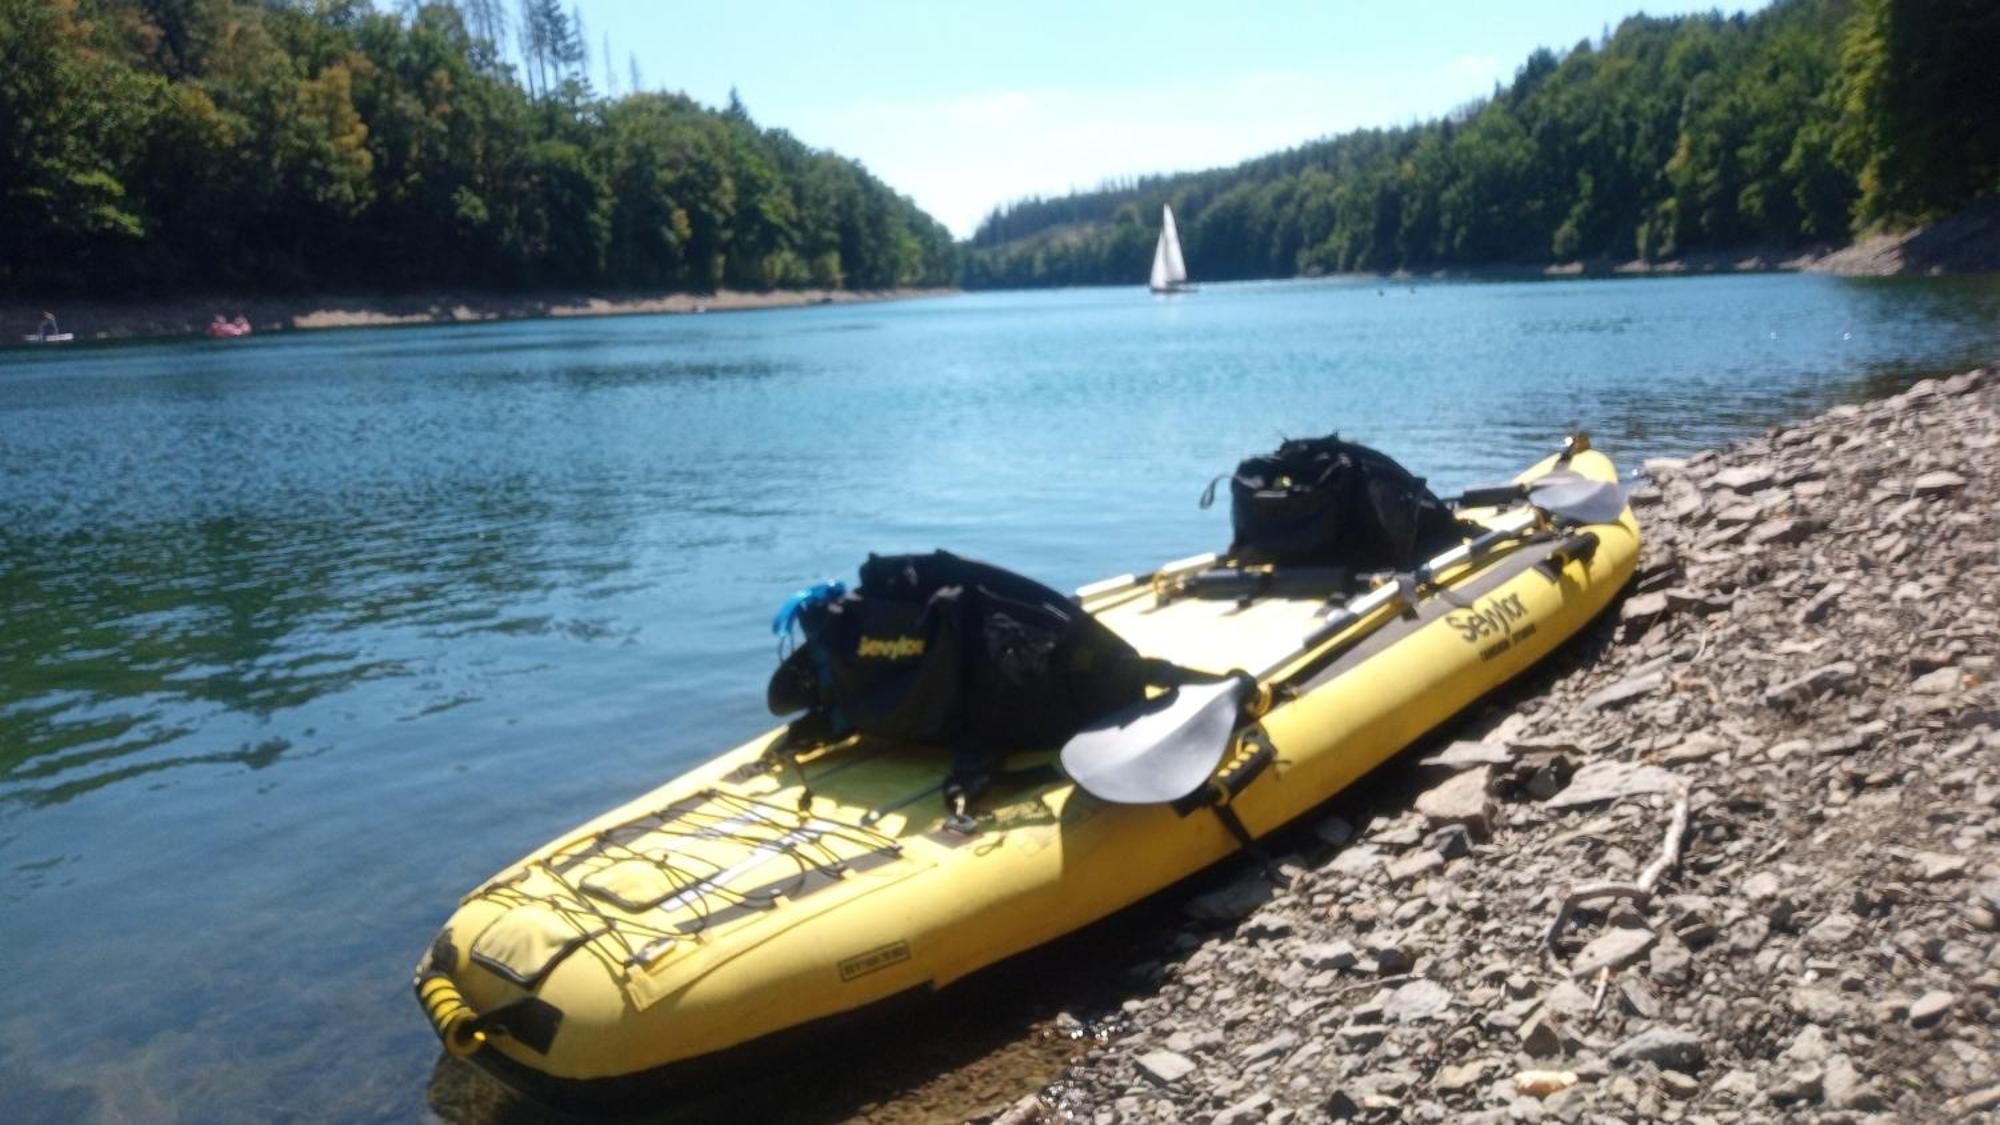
<box><xmin>0</xmin><ymin>0</ymin><xmax>956</xmax><ymax>296</ymax></box>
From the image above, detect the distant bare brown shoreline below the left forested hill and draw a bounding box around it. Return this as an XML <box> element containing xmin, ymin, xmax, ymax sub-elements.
<box><xmin>0</xmin><ymin>288</ymin><xmax>958</xmax><ymax>344</ymax></box>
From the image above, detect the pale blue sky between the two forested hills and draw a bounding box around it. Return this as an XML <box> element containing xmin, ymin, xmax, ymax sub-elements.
<box><xmin>580</xmin><ymin>0</ymin><xmax>1762</xmax><ymax>236</ymax></box>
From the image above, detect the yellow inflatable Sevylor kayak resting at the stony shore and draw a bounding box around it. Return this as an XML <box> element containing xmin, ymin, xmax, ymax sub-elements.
<box><xmin>416</xmin><ymin>440</ymin><xmax>1638</xmax><ymax>1103</ymax></box>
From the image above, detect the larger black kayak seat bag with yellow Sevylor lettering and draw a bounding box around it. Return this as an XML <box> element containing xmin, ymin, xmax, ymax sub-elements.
<box><xmin>768</xmin><ymin>550</ymin><xmax>1212</xmax><ymax>777</ymax></box>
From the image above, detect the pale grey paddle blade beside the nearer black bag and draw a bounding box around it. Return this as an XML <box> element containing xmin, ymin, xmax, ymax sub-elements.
<box><xmin>1062</xmin><ymin>679</ymin><xmax>1246</xmax><ymax>805</ymax></box>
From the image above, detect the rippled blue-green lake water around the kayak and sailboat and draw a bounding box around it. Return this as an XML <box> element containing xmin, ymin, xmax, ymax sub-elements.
<box><xmin>0</xmin><ymin>274</ymin><xmax>2000</xmax><ymax>1121</ymax></box>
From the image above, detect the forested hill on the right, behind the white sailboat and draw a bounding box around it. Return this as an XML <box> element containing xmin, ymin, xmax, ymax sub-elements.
<box><xmin>962</xmin><ymin>0</ymin><xmax>2000</xmax><ymax>288</ymax></box>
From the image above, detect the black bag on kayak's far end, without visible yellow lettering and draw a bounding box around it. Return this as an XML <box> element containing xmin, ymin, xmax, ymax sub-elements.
<box><xmin>1202</xmin><ymin>434</ymin><xmax>1472</xmax><ymax>573</ymax></box>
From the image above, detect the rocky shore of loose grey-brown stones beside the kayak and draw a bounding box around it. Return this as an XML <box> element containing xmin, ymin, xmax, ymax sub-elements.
<box><xmin>990</xmin><ymin>370</ymin><xmax>2000</xmax><ymax>1125</ymax></box>
